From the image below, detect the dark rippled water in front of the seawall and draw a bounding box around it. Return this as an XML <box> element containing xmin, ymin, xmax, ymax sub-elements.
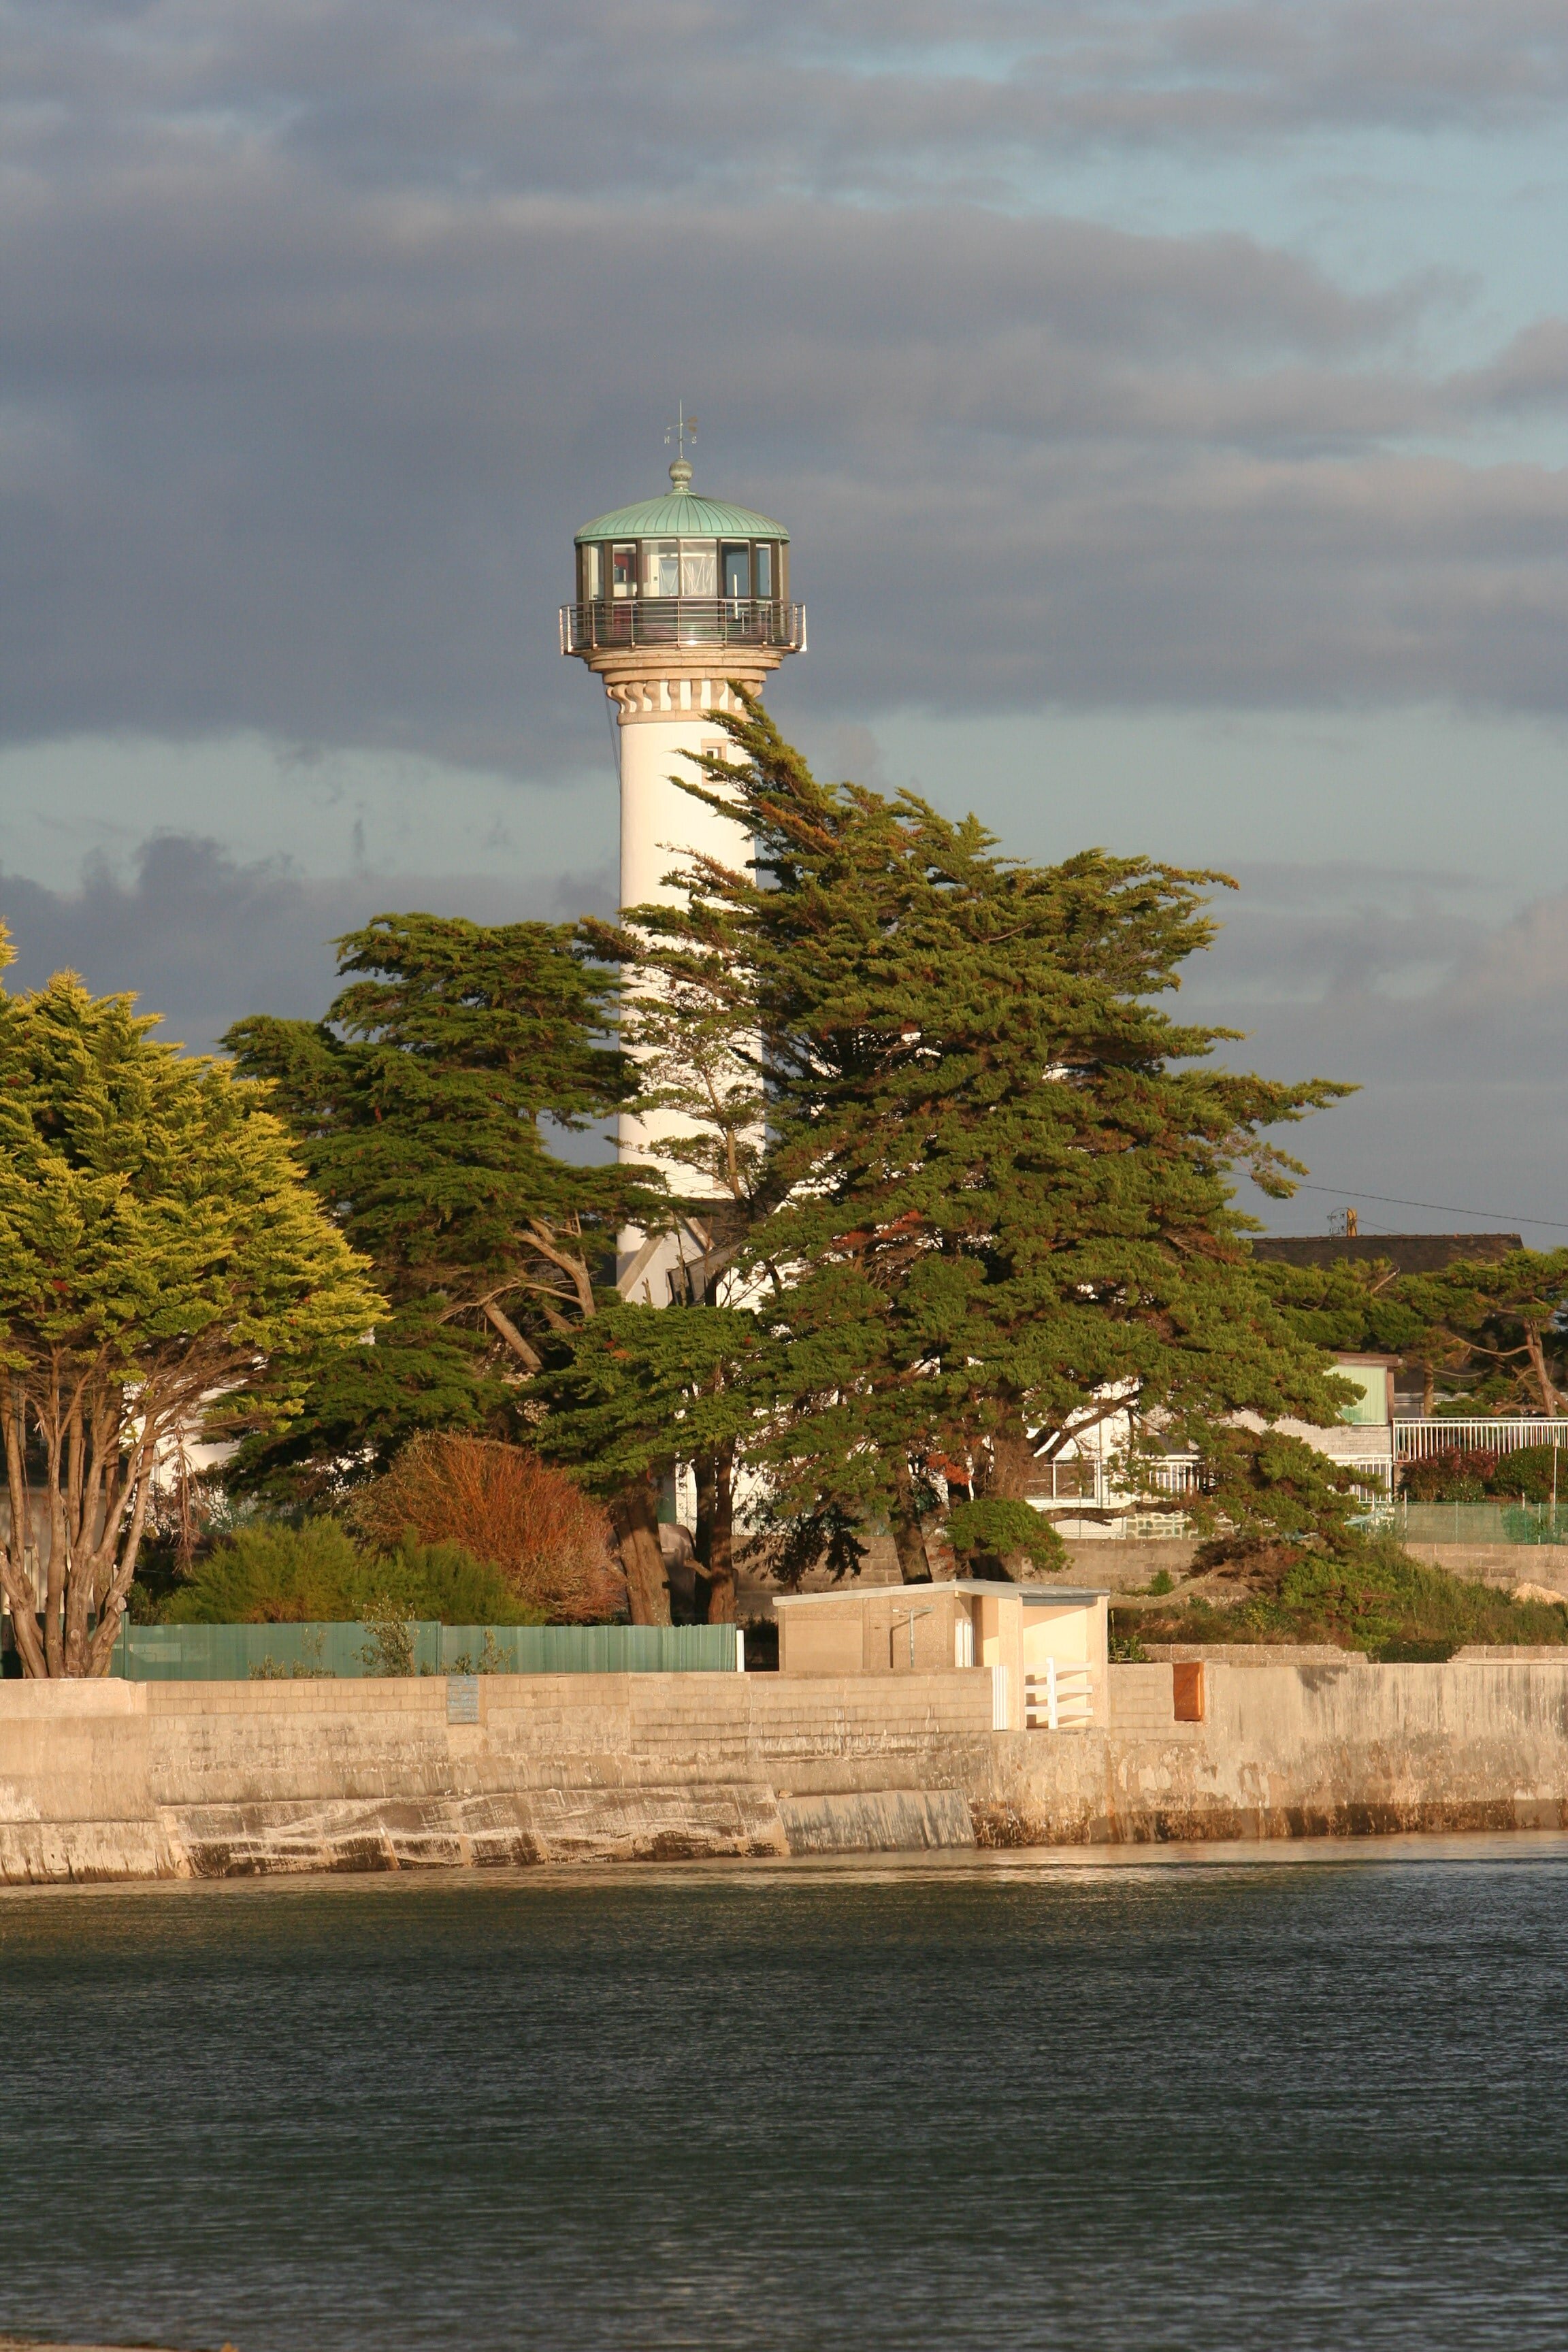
<box><xmin>0</xmin><ymin>1837</ymin><xmax>1568</xmax><ymax>2352</ymax></box>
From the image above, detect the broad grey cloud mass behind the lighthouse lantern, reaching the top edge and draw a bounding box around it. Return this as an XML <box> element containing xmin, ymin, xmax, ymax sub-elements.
<box><xmin>0</xmin><ymin>0</ymin><xmax>1568</xmax><ymax>774</ymax></box>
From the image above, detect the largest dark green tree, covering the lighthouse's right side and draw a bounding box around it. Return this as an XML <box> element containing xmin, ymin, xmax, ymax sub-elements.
<box><xmin>606</xmin><ymin>703</ymin><xmax>1347</xmax><ymax>1578</ymax></box>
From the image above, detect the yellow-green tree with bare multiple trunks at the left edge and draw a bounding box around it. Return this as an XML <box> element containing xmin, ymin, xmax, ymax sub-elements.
<box><xmin>0</xmin><ymin>932</ymin><xmax>383</xmax><ymax>1675</ymax></box>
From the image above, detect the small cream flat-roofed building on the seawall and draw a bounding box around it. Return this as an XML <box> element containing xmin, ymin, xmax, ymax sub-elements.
<box><xmin>773</xmin><ymin>1576</ymin><xmax>1109</xmax><ymax>1731</ymax></box>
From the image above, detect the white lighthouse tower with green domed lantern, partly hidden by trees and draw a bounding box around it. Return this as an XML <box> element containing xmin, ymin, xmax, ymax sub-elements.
<box><xmin>559</xmin><ymin>416</ymin><xmax>806</xmax><ymax>1305</ymax></box>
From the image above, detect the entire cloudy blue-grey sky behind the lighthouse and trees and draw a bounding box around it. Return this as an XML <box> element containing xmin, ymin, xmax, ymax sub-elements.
<box><xmin>0</xmin><ymin>0</ymin><xmax>1568</xmax><ymax>1247</ymax></box>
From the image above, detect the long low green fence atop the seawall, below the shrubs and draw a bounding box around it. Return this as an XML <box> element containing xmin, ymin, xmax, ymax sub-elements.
<box><xmin>113</xmin><ymin>1620</ymin><xmax>740</xmax><ymax>1682</ymax></box>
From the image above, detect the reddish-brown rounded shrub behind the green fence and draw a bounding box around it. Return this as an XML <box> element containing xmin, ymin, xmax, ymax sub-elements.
<box><xmin>353</xmin><ymin>1437</ymin><xmax>625</xmax><ymax>1625</ymax></box>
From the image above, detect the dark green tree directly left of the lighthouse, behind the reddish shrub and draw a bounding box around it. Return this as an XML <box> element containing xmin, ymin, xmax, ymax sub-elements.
<box><xmin>223</xmin><ymin>915</ymin><xmax>668</xmax><ymax>1620</ymax></box>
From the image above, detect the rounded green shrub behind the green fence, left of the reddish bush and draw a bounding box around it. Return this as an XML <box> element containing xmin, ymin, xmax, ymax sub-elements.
<box><xmin>165</xmin><ymin>1520</ymin><xmax>543</xmax><ymax>1625</ymax></box>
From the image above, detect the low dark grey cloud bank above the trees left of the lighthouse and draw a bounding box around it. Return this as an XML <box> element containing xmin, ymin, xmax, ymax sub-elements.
<box><xmin>0</xmin><ymin>835</ymin><xmax>614</xmax><ymax>1051</ymax></box>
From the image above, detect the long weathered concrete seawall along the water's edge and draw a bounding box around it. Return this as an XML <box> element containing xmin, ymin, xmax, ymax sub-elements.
<box><xmin>0</xmin><ymin>1661</ymin><xmax>1568</xmax><ymax>1882</ymax></box>
